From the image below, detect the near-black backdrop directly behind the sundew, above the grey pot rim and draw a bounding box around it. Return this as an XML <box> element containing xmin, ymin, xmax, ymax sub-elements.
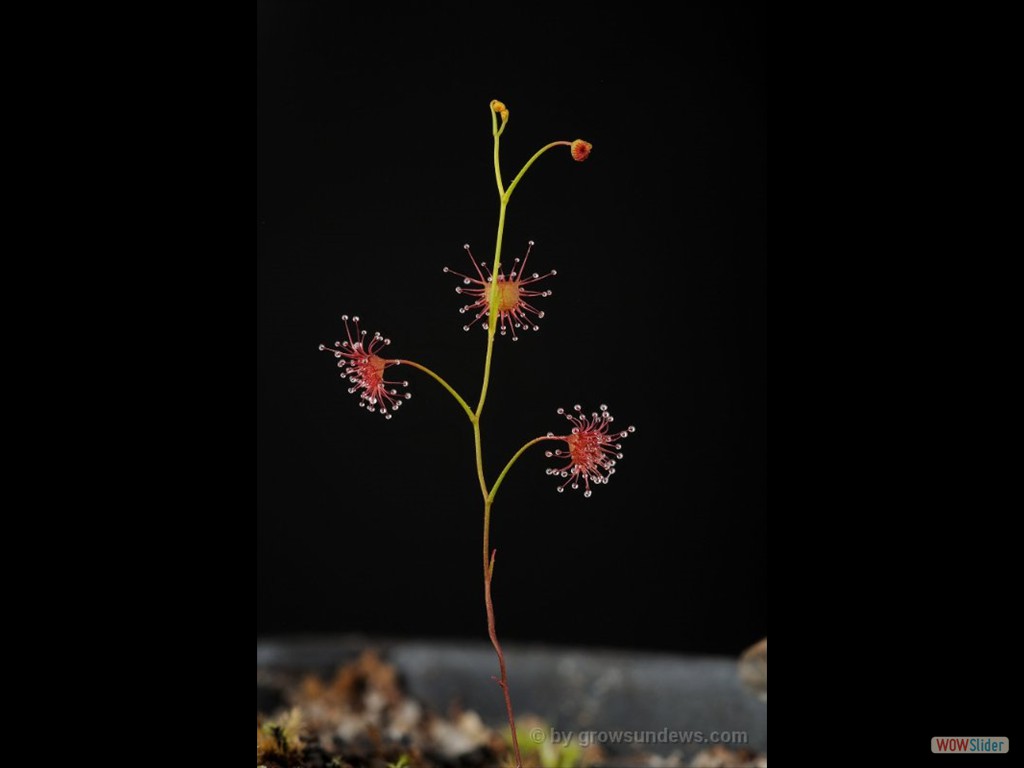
<box><xmin>256</xmin><ymin>3</ymin><xmax>767</xmax><ymax>653</ymax></box>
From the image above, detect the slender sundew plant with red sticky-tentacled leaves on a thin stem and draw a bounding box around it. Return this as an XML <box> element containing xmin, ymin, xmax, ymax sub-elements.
<box><xmin>319</xmin><ymin>100</ymin><xmax>634</xmax><ymax>766</ymax></box>
